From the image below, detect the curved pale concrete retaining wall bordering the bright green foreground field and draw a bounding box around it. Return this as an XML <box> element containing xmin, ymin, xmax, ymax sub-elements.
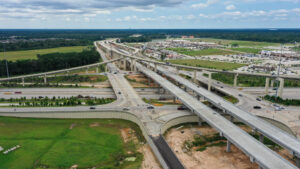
<box><xmin>0</xmin><ymin>112</ymin><xmax>169</xmax><ymax>169</ymax></box>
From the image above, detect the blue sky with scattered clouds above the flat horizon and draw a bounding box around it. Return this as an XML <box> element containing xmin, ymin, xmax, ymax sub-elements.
<box><xmin>0</xmin><ymin>0</ymin><xmax>300</xmax><ymax>29</ymax></box>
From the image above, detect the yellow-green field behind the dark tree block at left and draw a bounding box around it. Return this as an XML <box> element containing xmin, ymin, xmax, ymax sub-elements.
<box><xmin>0</xmin><ymin>46</ymin><xmax>87</xmax><ymax>61</ymax></box>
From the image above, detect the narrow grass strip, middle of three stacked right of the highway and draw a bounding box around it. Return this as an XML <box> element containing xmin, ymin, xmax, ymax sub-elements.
<box><xmin>168</xmin><ymin>48</ymin><xmax>237</xmax><ymax>56</ymax></box>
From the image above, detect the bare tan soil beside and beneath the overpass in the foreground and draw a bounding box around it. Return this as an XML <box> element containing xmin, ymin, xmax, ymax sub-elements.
<box><xmin>165</xmin><ymin>125</ymin><xmax>293</xmax><ymax>169</ymax></box>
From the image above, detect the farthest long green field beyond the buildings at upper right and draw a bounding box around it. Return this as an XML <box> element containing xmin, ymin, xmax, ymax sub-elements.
<box><xmin>191</xmin><ymin>38</ymin><xmax>280</xmax><ymax>48</ymax></box>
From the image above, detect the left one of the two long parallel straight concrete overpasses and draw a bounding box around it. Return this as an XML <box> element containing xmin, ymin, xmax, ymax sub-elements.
<box><xmin>101</xmin><ymin>41</ymin><xmax>296</xmax><ymax>169</ymax></box>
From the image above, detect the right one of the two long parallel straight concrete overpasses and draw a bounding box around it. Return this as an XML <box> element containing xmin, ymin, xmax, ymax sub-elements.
<box><xmin>106</xmin><ymin>41</ymin><xmax>300</xmax><ymax>168</ymax></box>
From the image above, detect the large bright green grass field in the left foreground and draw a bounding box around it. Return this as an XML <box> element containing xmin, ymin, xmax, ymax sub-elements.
<box><xmin>0</xmin><ymin>117</ymin><xmax>143</xmax><ymax>169</ymax></box>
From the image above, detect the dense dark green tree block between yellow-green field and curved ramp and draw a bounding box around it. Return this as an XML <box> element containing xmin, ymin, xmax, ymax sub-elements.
<box><xmin>0</xmin><ymin>47</ymin><xmax>101</xmax><ymax>77</ymax></box>
